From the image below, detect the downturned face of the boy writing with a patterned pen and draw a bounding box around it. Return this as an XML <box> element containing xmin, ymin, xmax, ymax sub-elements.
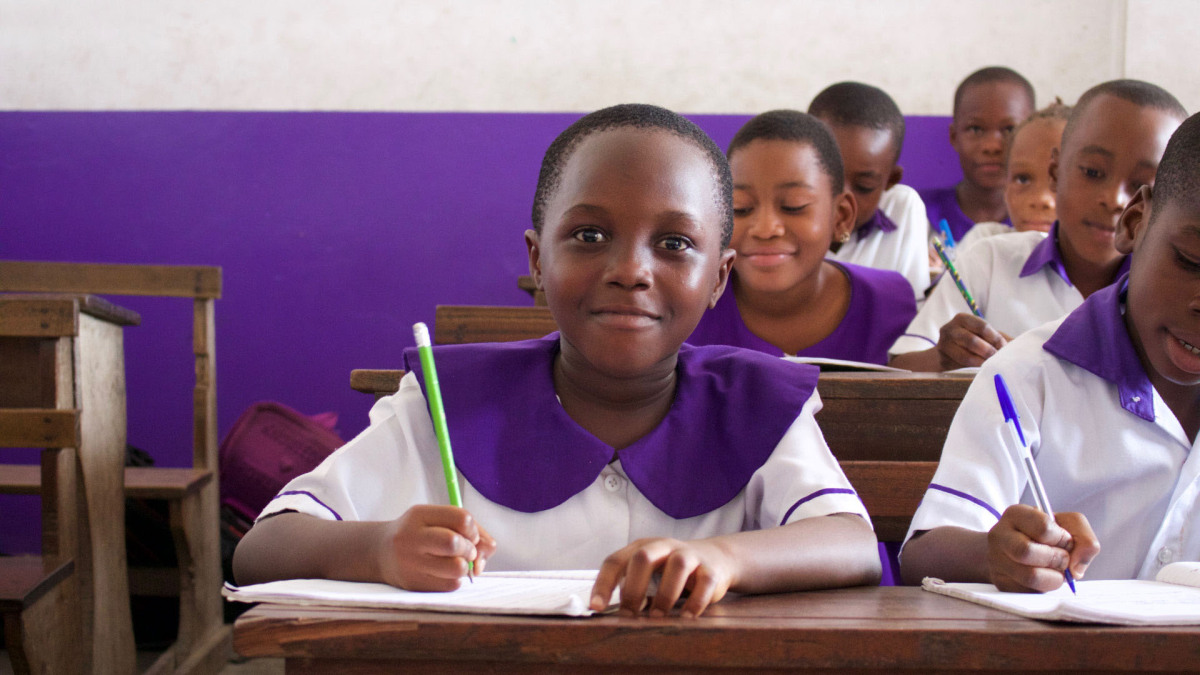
<box><xmin>1050</xmin><ymin>94</ymin><xmax>1180</xmax><ymax>265</ymax></box>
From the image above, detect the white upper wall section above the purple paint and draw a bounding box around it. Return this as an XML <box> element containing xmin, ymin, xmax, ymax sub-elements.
<box><xmin>0</xmin><ymin>0</ymin><xmax>1200</xmax><ymax>114</ymax></box>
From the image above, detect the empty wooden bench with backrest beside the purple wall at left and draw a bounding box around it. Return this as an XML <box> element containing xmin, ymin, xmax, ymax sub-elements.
<box><xmin>0</xmin><ymin>261</ymin><xmax>230</xmax><ymax>673</ymax></box>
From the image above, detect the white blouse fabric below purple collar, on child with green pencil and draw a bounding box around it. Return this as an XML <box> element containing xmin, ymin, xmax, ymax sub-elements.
<box><xmin>259</xmin><ymin>372</ymin><xmax>870</xmax><ymax>571</ymax></box>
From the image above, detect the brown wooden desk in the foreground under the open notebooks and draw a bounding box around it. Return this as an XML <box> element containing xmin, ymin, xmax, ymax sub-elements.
<box><xmin>234</xmin><ymin>587</ymin><xmax>1200</xmax><ymax>675</ymax></box>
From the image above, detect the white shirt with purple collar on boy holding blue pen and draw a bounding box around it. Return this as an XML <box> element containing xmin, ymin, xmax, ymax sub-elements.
<box><xmin>906</xmin><ymin>282</ymin><xmax>1200</xmax><ymax>579</ymax></box>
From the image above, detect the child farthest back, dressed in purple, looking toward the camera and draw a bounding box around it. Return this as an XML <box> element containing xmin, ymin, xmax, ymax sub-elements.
<box><xmin>919</xmin><ymin>66</ymin><xmax>1034</xmax><ymax>241</ymax></box>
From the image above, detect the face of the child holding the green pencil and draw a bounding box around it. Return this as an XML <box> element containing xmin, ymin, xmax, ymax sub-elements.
<box><xmin>526</xmin><ymin>127</ymin><xmax>733</xmax><ymax>377</ymax></box>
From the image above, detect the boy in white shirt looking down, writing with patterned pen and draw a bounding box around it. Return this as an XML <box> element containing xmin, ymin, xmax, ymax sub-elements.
<box><xmin>890</xmin><ymin>79</ymin><xmax>1187</xmax><ymax>371</ymax></box>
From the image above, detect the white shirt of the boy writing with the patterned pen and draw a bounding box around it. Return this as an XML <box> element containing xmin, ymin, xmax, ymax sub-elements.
<box><xmin>888</xmin><ymin>225</ymin><xmax>1099</xmax><ymax>354</ymax></box>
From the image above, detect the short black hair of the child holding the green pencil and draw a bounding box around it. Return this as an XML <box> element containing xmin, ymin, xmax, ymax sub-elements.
<box><xmin>533</xmin><ymin>103</ymin><xmax>733</xmax><ymax>249</ymax></box>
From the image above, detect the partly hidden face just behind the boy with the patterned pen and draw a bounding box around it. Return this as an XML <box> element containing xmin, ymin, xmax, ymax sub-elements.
<box><xmin>1004</xmin><ymin>118</ymin><xmax>1067</xmax><ymax>232</ymax></box>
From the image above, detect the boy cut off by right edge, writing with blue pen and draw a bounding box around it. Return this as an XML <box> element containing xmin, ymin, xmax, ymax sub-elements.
<box><xmin>901</xmin><ymin>109</ymin><xmax>1200</xmax><ymax>583</ymax></box>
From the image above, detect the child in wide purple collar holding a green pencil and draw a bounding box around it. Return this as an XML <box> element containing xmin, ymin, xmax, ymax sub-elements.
<box><xmin>234</xmin><ymin>104</ymin><xmax>880</xmax><ymax>616</ymax></box>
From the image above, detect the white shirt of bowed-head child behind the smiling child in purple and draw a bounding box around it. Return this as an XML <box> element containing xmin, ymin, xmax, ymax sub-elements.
<box><xmin>828</xmin><ymin>185</ymin><xmax>929</xmax><ymax>300</ymax></box>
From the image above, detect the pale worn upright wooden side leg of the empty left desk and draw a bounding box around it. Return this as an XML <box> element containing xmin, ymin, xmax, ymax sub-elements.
<box><xmin>74</xmin><ymin>315</ymin><xmax>137</xmax><ymax>674</ymax></box>
